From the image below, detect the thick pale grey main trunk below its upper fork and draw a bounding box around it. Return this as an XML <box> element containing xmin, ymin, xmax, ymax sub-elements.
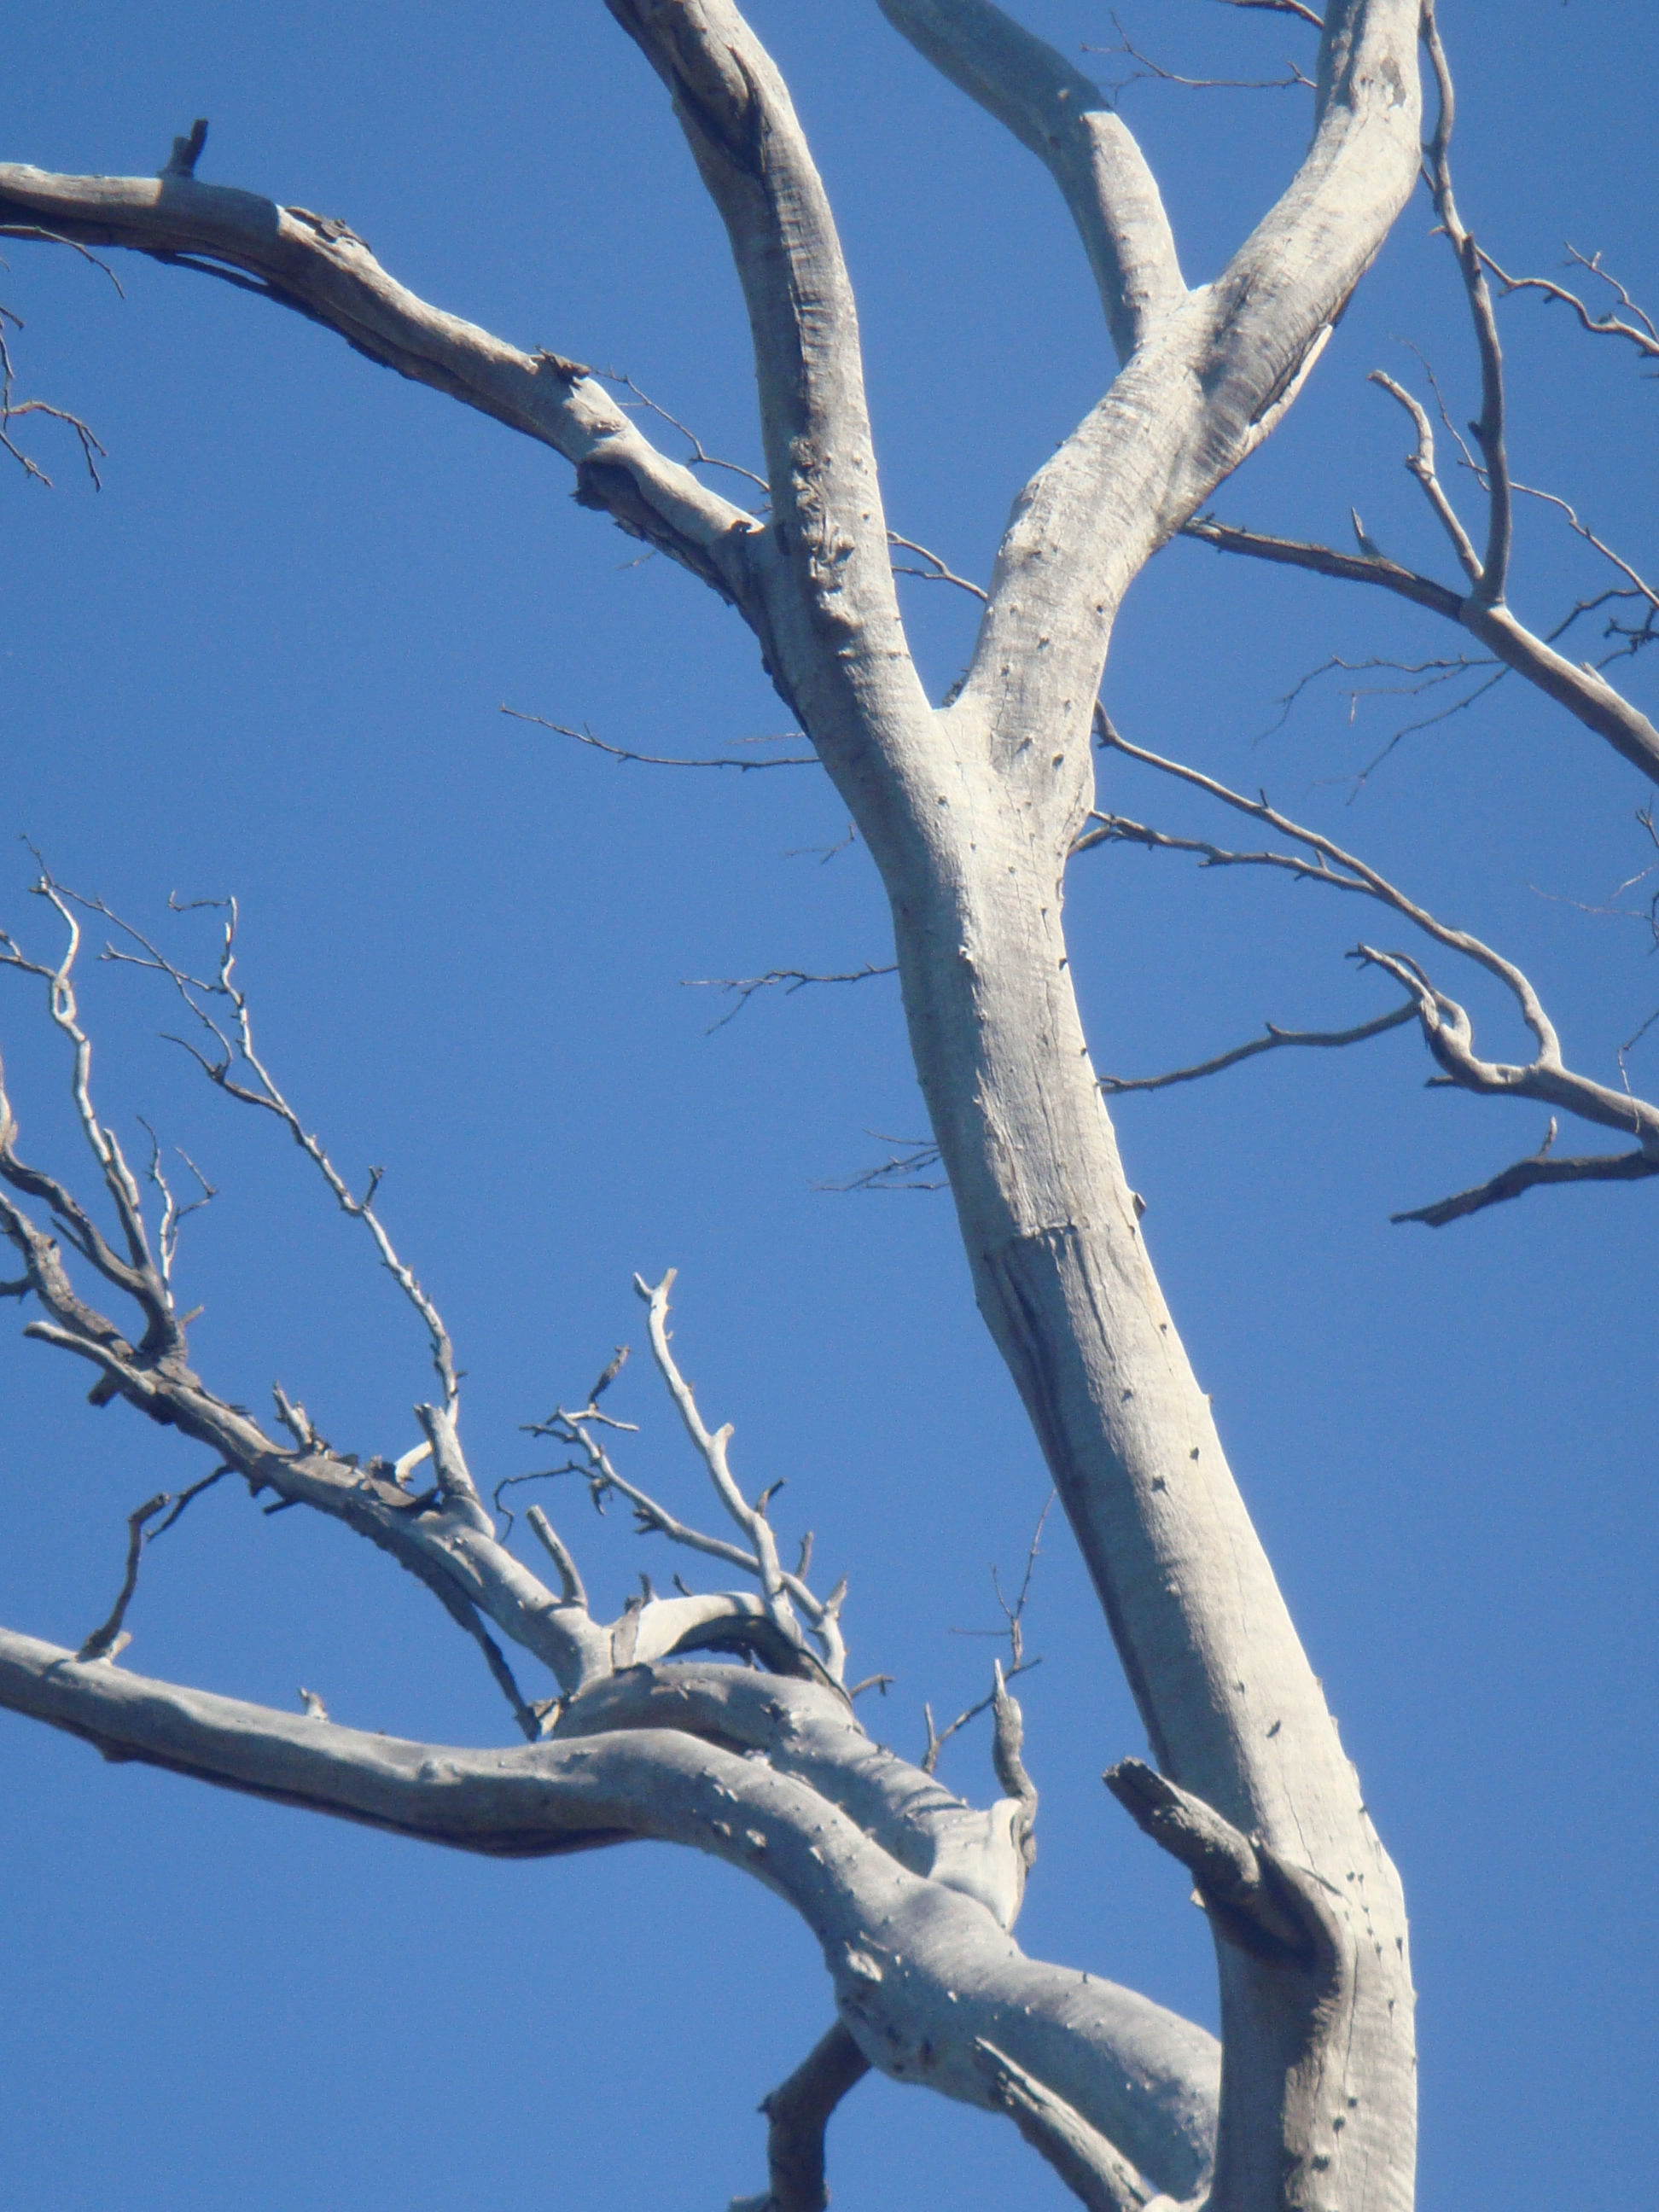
<box><xmin>878</xmin><ymin>754</ymin><xmax>1416</xmax><ymax>2212</ymax></box>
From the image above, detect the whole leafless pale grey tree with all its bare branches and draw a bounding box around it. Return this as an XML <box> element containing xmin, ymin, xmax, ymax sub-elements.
<box><xmin>0</xmin><ymin>0</ymin><xmax>1659</xmax><ymax>2212</ymax></box>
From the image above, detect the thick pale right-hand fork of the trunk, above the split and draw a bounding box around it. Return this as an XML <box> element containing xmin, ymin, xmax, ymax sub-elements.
<box><xmin>956</xmin><ymin>0</ymin><xmax>1417</xmax><ymax>852</ymax></box>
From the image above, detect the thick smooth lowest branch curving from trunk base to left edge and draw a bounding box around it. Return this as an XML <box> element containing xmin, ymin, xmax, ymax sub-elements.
<box><xmin>0</xmin><ymin>1630</ymin><xmax>1217</xmax><ymax>2194</ymax></box>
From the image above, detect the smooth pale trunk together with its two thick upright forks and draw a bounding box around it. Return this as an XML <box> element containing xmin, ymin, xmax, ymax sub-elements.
<box><xmin>613</xmin><ymin>0</ymin><xmax>1420</xmax><ymax>2212</ymax></box>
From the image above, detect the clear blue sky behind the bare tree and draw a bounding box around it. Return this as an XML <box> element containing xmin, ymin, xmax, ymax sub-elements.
<box><xmin>0</xmin><ymin>0</ymin><xmax>1659</xmax><ymax>2212</ymax></box>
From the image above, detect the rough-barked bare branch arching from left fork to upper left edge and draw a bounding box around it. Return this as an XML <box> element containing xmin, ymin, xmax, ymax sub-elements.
<box><xmin>0</xmin><ymin>143</ymin><xmax>759</xmax><ymax>599</ymax></box>
